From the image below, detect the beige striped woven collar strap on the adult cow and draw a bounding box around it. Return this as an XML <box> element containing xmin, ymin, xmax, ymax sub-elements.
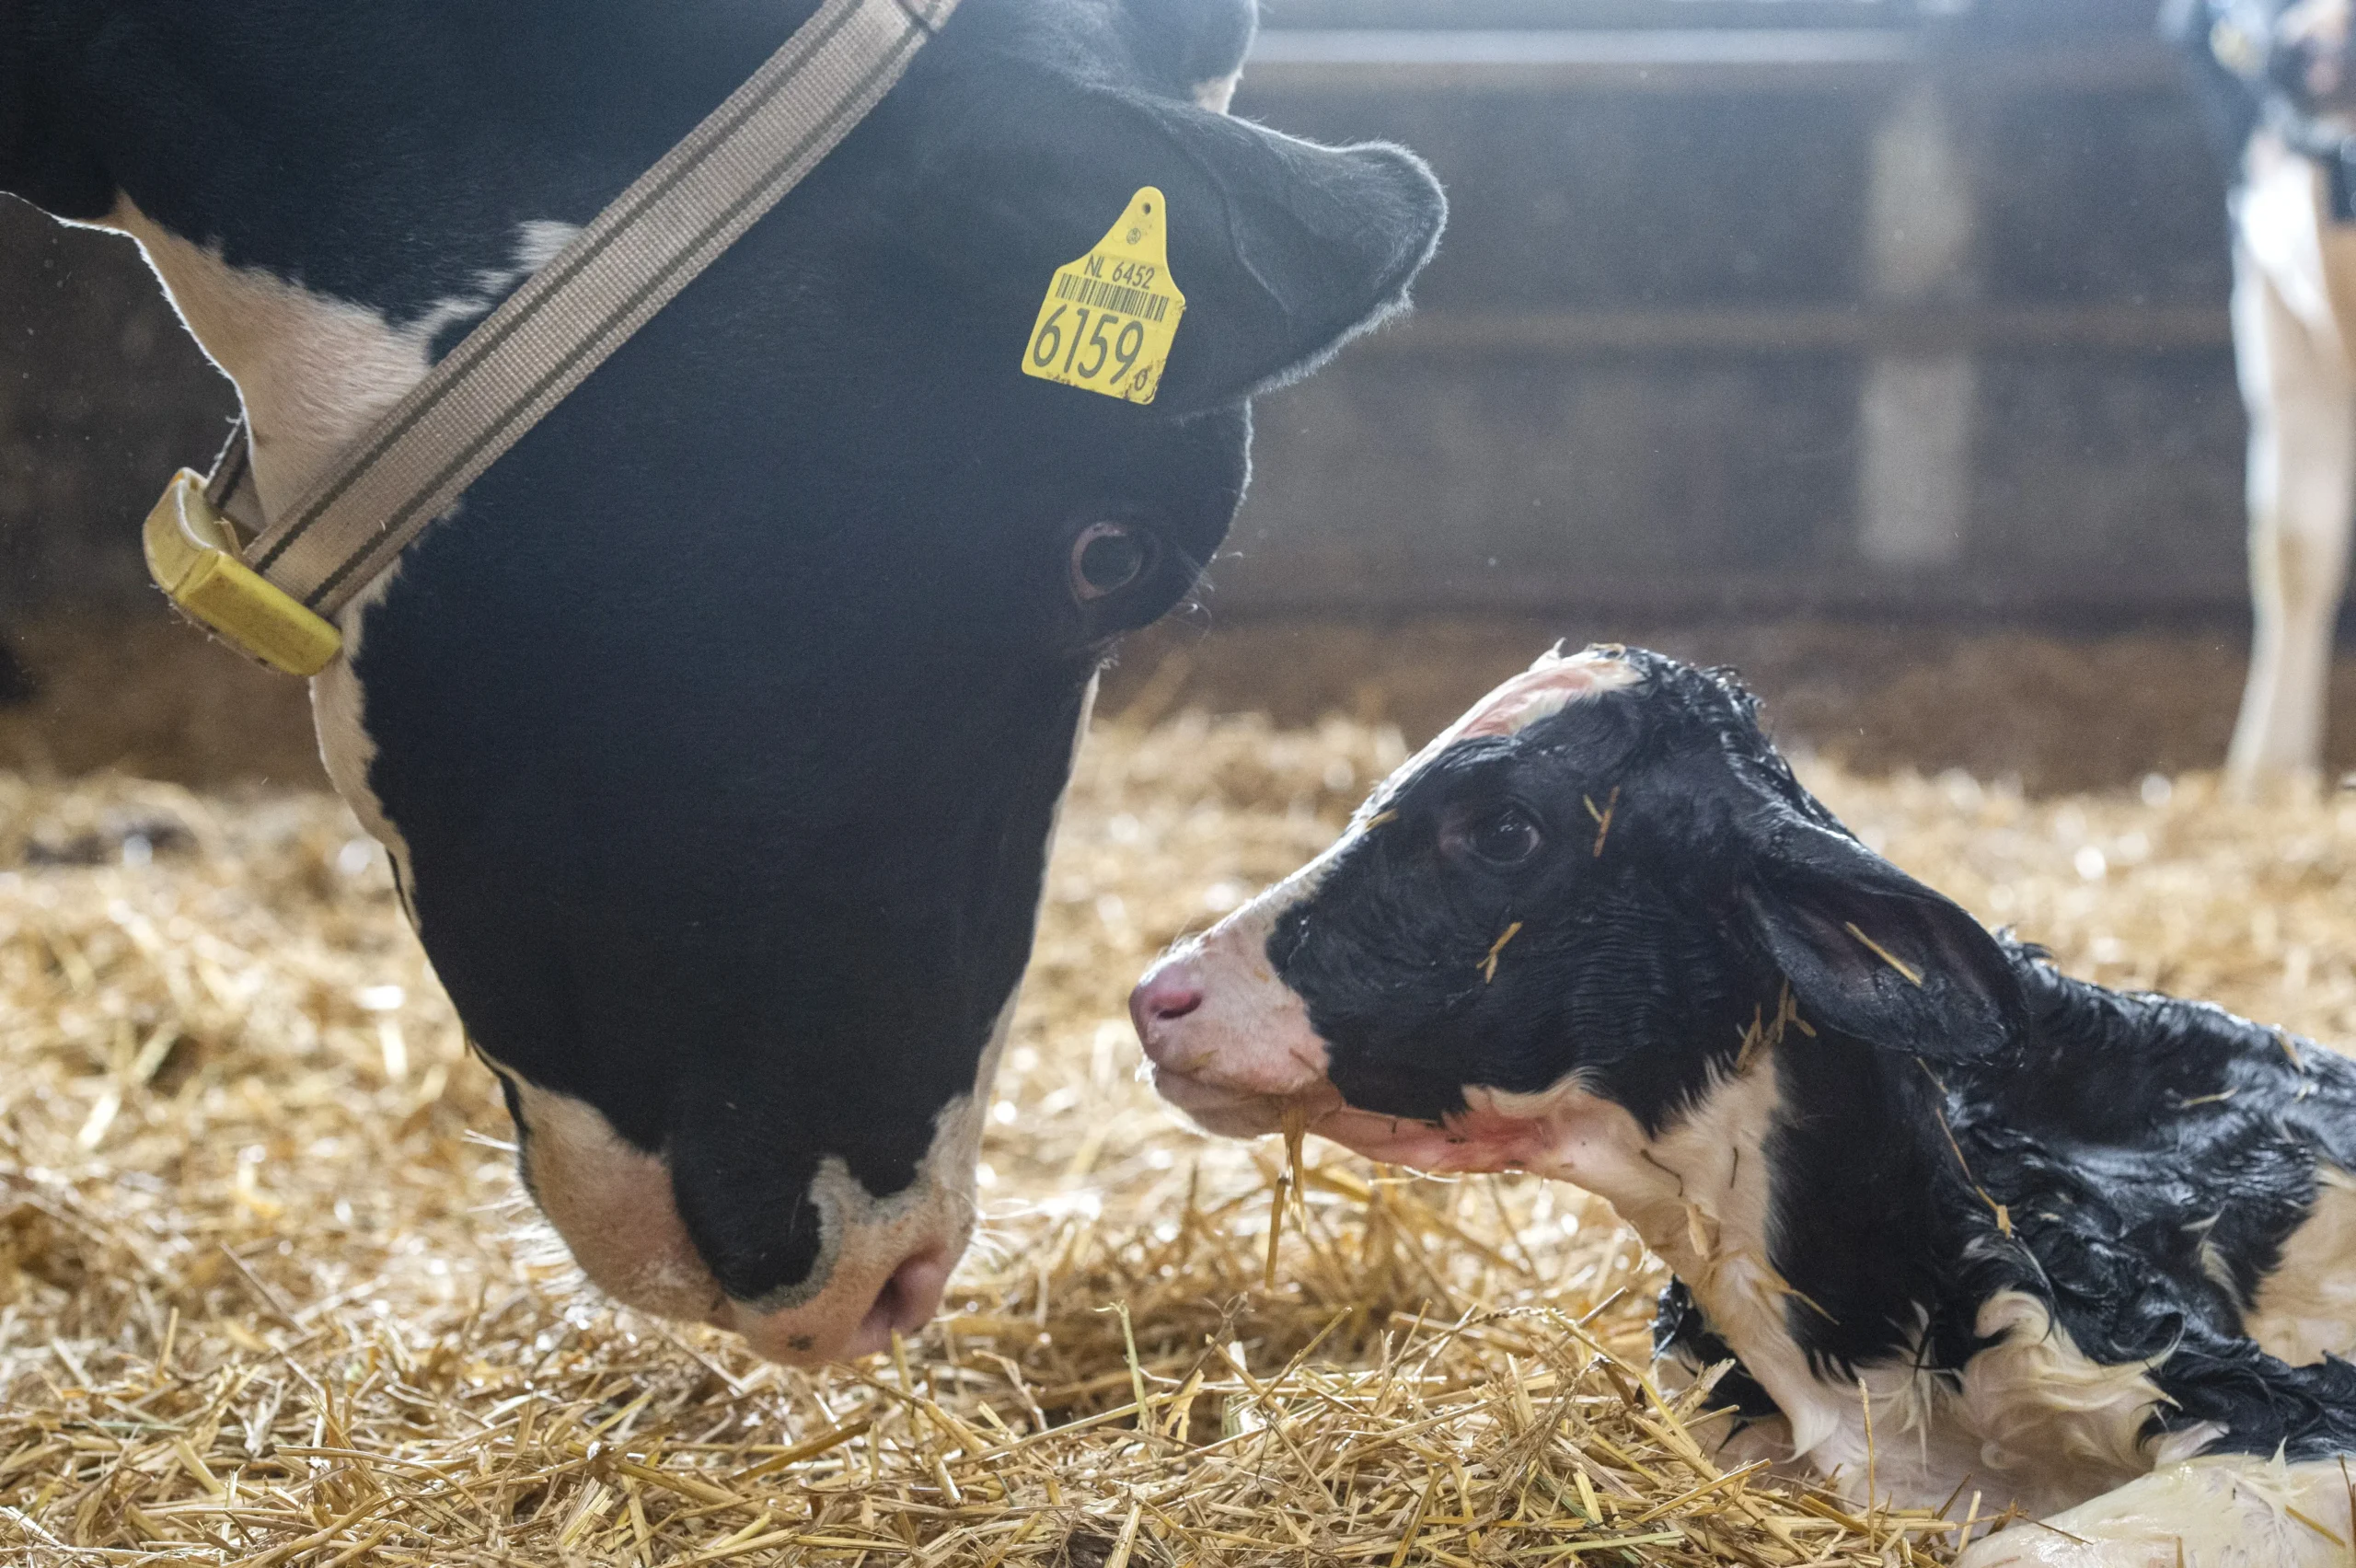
<box><xmin>151</xmin><ymin>0</ymin><xmax>956</xmax><ymax>674</ymax></box>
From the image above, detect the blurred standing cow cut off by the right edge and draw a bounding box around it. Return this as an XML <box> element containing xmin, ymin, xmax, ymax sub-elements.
<box><xmin>2163</xmin><ymin>0</ymin><xmax>2356</xmax><ymax>791</ymax></box>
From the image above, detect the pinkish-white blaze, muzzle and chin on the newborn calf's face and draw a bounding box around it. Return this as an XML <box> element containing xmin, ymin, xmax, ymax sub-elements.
<box><xmin>1131</xmin><ymin>648</ymin><xmax>1637</xmax><ymax>1135</ymax></box>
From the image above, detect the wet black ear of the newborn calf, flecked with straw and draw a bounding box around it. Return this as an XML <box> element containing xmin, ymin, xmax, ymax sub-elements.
<box><xmin>1741</xmin><ymin>813</ymin><xmax>2027</xmax><ymax>1062</ymax></box>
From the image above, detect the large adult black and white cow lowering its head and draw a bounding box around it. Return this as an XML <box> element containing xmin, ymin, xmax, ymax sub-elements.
<box><xmin>0</xmin><ymin>0</ymin><xmax>1442</xmax><ymax>1361</ymax></box>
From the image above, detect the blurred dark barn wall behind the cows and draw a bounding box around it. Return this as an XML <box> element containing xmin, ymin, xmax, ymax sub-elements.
<box><xmin>0</xmin><ymin>0</ymin><xmax>2243</xmax><ymax>617</ymax></box>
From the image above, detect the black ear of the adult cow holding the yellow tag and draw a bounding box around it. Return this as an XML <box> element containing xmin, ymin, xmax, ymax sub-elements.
<box><xmin>909</xmin><ymin>56</ymin><xmax>1447</xmax><ymax>414</ymax></box>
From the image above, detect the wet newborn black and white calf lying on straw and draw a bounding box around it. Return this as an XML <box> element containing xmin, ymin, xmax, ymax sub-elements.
<box><xmin>1131</xmin><ymin>648</ymin><xmax>2356</xmax><ymax>1568</ymax></box>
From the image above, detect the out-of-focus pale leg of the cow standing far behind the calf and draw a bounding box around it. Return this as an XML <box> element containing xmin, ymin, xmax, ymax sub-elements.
<box><xmin>2226</xmin><ymin>136</ymin><xmax>2356</xmax><ymax>791</ymax></box>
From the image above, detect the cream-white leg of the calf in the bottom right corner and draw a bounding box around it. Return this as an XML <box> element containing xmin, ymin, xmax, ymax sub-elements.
<box><xmin>1956</xmin><ymin>1455</ymin><xmax>2351</xmax><ymax>1568</ymax></box>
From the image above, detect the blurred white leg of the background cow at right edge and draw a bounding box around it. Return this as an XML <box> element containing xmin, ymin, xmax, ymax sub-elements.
<box><xmin>2226</xmin><ymin>221</ymin><xmax>2356</xmax><ymax>793</ymax></box>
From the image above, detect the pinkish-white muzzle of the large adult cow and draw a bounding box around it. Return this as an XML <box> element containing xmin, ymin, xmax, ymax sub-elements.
<box><xmin>503</xmin><ymin>1083</ymin><xmax>973</xmax><ymax>1366</ymax></box>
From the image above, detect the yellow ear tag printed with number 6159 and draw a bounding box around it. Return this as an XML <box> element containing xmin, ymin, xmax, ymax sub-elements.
<box><xmin>1022</xmin><ymin>186</ymin><xmax>1185</xmax><ymax>403</ymax></box>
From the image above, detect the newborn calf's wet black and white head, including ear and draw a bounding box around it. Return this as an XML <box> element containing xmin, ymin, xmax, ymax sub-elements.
<box><xmin>1131</xmin><ymin>648</ymin><xmax>2021</xmax><ymax>1175</ymax></box>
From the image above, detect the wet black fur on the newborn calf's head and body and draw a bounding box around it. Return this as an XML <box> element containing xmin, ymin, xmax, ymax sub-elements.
<box><xmin>1300</xmin><ymin>652</ymin><xmax>2356</xmax><ymax>1458</ymax></box>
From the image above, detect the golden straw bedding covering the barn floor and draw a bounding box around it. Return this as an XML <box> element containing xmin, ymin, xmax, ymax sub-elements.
<box><xmin>0</xmin><ymin>716</ymin><xmax>2356</xmax><ymax>1568</ymax></box>
